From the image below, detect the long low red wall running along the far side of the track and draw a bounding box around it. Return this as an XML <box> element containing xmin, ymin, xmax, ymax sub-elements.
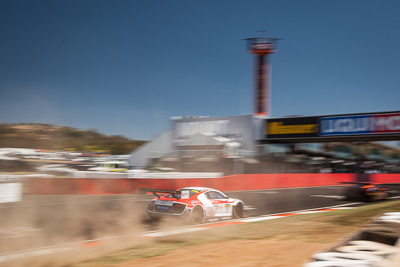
<box><xmin>24</xmin><ymin>173</ymin><xmax>400</xmax><ymax>195</ymax></box>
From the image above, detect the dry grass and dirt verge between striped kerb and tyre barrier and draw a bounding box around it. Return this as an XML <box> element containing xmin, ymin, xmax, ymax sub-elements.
<box><xmin>74</xmin><ymin>201</ymin><xmax>400</xmax><ymax>267</ymax></box>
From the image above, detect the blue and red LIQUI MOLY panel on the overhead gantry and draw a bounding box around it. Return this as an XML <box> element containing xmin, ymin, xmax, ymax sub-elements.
<box><xmin>319</xmin><ymin>113</ymin><xmax>400</xmax><ymax>136</ymax></box>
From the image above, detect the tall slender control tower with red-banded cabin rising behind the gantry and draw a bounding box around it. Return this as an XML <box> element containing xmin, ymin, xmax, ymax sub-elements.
<box><xmin>244</xmin><ymin>33</ymin><xmax>280</xmax><ymax>117</ymax></box>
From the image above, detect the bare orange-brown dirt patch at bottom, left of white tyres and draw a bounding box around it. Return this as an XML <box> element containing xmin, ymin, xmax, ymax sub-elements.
<box><xmin>112</xmin><ymin>240</ymin><xmax>327</xmax><ymax>267</ymax></box>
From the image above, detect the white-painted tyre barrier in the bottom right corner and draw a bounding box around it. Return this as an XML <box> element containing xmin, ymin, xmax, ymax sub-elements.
<box><xmin>304</xmin><ymin>212</ymin><xmax>400</xmax><ymax>267</ymax></box>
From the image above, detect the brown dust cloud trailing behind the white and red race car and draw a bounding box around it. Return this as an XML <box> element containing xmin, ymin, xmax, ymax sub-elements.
<box><xmin>0</xmin><ymin>195</ymin><xmax>162</xmax><ymax>267</ymax></box>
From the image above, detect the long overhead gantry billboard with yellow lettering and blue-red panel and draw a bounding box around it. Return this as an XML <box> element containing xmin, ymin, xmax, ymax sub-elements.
<box><xmin>264</xmin><ymin>112</ymin><xmax>400</xmax><ymax>142</ymax></box>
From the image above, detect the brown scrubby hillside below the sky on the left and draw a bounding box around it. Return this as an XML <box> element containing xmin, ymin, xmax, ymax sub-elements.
<box><xmin>0</xmin><ymin>123</ymin><xmax>146</xmax><ymax>155</ymax></box>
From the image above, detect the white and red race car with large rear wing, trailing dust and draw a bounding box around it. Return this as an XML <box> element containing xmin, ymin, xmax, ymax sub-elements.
<box><xmin>139</xmin><ymin>187</ymin><xmax>245</xmax><ymax>224</ymax></box>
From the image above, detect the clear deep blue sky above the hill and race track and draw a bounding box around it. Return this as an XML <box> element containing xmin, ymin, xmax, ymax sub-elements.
<box><xmin>0</xmin><ymin>0</ymin><xmax>400</xmax><ymax>140</ymax></box>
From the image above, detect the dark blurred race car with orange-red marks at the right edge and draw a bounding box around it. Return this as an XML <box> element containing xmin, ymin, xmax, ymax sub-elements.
<box><xmin>343</xmin><ymin>182</ymin><xmax>389</xmax><ymax>201</ymax></box>
